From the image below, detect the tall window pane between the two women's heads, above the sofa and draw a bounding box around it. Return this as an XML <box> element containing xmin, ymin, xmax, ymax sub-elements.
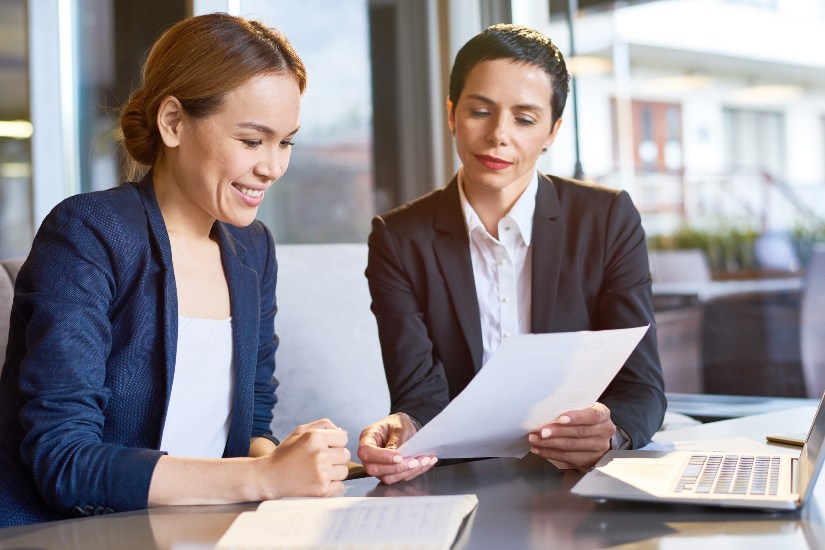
<box><xmin>239</xmin><ymin>0</ymin><xmax>375</xmax><ymax>243</ymax></box>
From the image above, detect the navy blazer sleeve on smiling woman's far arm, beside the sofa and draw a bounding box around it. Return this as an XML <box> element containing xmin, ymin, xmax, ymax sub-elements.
<box><xmin>252</xmin><ymin>222</ymin><xmax>278</xmax><ymax>443</ymax></box>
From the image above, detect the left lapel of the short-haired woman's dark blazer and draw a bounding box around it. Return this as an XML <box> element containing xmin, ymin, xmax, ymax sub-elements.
<box><xmin>433</xmin><ymin>178</ymin><xmax>483</xmax><ymax>372</ymax></box>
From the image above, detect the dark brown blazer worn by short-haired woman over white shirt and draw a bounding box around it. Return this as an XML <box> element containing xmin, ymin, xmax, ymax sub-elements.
<box><xmin>366</xmin><ymin>176</ymin><xmax>666</xmax><ymax>448</ymax></box>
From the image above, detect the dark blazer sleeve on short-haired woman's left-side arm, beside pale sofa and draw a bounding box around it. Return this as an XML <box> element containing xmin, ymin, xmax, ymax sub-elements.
<box><xmin>366</xmin><ymin>217</ymin><xmax>450</xmax><ymax>424</ymax></box>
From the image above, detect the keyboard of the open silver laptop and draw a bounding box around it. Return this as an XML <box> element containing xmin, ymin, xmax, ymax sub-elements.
<box><xmin>676</xmin><ymin>454</ymin><xmax>779</xmax><ymax>495</ymax></box>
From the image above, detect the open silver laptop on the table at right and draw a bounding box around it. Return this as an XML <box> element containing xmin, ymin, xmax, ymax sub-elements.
<box><xmin>572</xmin><ymin>394</ymin><xmax>825</xmax><ymax>510</ymax></box>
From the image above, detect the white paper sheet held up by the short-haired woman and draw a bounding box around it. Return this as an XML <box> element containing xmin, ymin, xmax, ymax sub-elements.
<box><xmin>398</xmin><ymin>325</ymin><xmax>649</xmax><ymax>458</ymax></box>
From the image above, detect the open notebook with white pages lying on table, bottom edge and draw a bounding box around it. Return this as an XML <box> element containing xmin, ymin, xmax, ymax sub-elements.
<box><xmin>215</xmin><ymin>495</ymin><xmax>478</xmax><ymax>550</ymax></box>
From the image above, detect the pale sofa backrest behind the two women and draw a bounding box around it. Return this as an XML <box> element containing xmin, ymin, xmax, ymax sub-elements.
<box><xmin>0</xmin><ymin>250</ymin><xmax>390</xmax><ymax>457</ymax></box>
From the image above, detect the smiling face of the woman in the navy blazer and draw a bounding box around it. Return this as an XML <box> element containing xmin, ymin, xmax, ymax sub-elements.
<box><xmin>155</xmin><ymin>74</ymin><xmax>301</xmax><ymax>232</ymax></box>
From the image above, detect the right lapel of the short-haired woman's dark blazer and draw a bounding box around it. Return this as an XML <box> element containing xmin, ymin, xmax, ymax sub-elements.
<box><xmin>530</xmin><ymin>174</ymin><xmax>565</xmax><ymax>333</ymax></box>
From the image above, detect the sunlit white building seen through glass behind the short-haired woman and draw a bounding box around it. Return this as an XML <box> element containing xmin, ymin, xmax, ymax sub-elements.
<box><xmin>536</xmin><ymin>0</ymin><xmax>825</xmax><ymax>236</ymax></box>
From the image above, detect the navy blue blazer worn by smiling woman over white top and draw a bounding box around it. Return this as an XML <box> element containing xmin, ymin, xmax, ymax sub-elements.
<box><xmin>0</xmin><ymin>174</ymin><xmax>277</xmax><ymax>525</ymax></box>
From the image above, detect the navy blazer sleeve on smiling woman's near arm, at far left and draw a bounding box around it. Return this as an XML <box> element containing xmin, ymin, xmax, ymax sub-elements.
<box><xmin>13</xmin><ymin>199</ymin><xmax>164</xmax><ymax>515</ymax></box>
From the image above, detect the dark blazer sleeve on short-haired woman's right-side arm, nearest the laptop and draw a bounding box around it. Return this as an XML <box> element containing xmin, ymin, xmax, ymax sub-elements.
<box><xmin>596</xmin><ymin>191</ymin><xmax>667</xmax><ymax>449</ymax></box>
